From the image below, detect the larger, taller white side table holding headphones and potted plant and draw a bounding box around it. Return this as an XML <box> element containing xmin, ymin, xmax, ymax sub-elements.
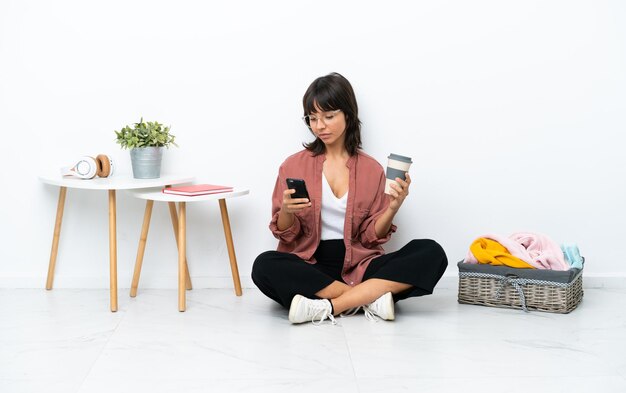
<box><xmin>39</xmin><ymin>173</ymin><xmax>194</xmax><ymax>312</ymax></box>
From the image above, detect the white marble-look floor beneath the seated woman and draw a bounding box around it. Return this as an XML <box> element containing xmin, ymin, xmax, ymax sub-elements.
<box><xmin>0</xmin><ymin>289</ymin><xmax>626</xmax><ymax>393</ymax></box>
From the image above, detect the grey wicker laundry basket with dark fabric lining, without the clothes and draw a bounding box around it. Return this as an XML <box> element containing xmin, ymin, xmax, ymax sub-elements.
<box><xmin>457</xmin><ymin>262</ymin><xmax>583</xmax><ymax>314</ymax></box>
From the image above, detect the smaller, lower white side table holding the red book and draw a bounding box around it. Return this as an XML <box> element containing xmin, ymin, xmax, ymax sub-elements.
<box><xmin>129</xmin><ymin>188</ymin><xmax>250</xmax><ymax>311</ymax></box>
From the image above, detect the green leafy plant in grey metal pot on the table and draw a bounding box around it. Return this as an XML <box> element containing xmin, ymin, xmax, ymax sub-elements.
<box><xmin>115</xmin><ymin>117</ymin><xmax>178</xmax><ymax>179</ymax></box>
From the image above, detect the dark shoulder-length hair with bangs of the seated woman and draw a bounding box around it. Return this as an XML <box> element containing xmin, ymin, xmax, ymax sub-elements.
<box><xmin>302</xmin><ymin>72</ymin><xmax>361</xmax><ymax>156</ymax></box>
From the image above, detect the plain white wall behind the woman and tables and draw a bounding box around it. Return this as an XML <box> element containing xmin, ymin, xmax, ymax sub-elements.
<box><xmin>0</xmin><ymin>0</ymin><xmax>626</xmax><ymax>287</ymax></box>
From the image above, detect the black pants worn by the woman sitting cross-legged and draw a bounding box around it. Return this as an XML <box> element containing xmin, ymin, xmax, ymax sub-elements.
<box><xmin>252</xmin><ymin>239</ymin><xmax>448</xmax><ymax>308</ymax></box>
